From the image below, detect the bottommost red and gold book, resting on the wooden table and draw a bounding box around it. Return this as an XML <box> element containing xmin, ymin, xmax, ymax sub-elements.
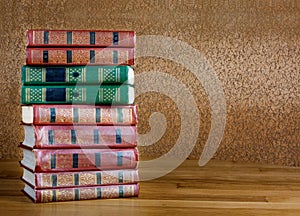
<box><xmin>23</xmin><ymin>183</ymin><xmax>139</xmax><ymax>203</ymax></box>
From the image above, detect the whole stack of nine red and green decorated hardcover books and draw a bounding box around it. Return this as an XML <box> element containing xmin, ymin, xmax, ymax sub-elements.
<box><xmin>20</xmin><ymin>30</ymin><xmax>139</xmax><ymax>202</ymax></box>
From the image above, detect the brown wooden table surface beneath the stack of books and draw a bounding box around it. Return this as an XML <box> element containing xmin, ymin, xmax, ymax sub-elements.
<box><xmin>0</xmin><ymin>160</ymin><xmax>300</xmax><ymax>216</ymax></box>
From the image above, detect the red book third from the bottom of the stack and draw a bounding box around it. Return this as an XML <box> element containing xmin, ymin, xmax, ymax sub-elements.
<box><xmin>20</xmin><ymin>145</ymin><xmax>138</xmax><ymax>172</ymax></box>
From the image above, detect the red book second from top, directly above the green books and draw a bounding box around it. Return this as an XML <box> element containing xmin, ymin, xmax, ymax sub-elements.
<box><xmin>26</xmin><ymin>47</ymin><xmax>134</xmax><ymax>66</ymax></box>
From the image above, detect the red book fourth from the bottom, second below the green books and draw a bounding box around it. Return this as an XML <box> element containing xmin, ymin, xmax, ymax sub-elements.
<box><xmin>22</xmin><ymin>125</ymin><xmax>137</xmax><ymax>149</ymax></box>
